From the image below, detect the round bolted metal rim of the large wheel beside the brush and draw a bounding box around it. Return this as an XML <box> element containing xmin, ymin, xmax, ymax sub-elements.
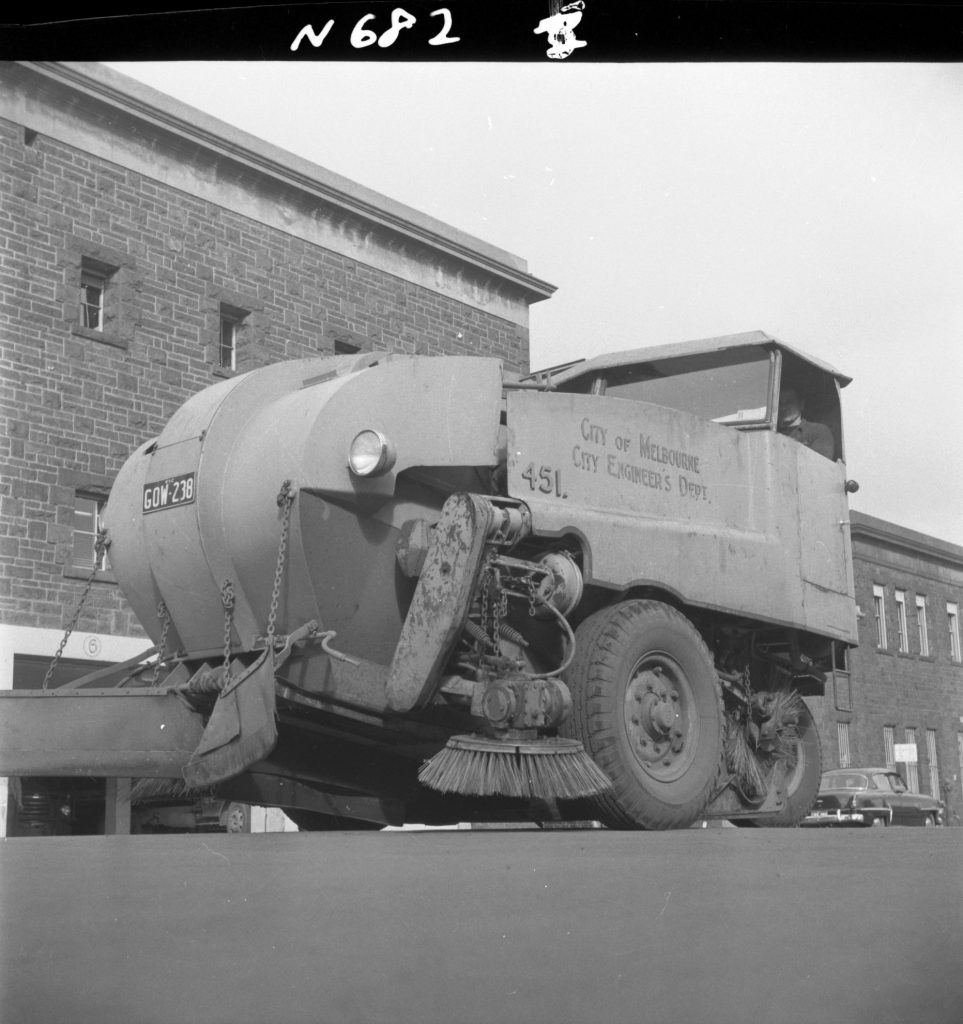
<box><xmin>623</xmin><ymin>651</ymin><xmax>699</xmax><ymax>782</ymax></box>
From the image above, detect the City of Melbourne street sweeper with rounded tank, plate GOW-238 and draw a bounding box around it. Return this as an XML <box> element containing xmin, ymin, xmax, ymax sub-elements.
<box><xmin>0</xmin><ymin>332</ymin><xmax>856</xmax><ymax>829</ymax></box>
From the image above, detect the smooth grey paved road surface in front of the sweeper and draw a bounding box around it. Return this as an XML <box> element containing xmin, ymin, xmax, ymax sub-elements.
<box><xmin>0</xmin><ymin>828</ymin><xmax>963</xmax><ymax>1024</ymax></box>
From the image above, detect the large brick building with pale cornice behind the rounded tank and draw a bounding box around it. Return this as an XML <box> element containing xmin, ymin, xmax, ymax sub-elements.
<box><xmin>0</xmin><ymin>61</ymin><xmax>553</xmax><ymax>821</ymax></box>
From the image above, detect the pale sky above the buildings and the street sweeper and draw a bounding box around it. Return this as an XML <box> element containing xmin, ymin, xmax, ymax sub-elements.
<box><xmin>110</xmin><ymin>60</ymin><xmax>963</xmax><ymax>545</ymax></box>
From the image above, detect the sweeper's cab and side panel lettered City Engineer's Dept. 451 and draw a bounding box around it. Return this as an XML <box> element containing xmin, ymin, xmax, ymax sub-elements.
<box><xmin>508</xmin><ymin>332</ymin><xmax>856</xmax><ymax>655</ymax></box>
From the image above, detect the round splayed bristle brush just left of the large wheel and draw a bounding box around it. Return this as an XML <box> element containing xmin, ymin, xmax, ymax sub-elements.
<box><xmin>418</xmin><ymin>736</ymin><xmax>612</xmax><ymax>800</ymax></box>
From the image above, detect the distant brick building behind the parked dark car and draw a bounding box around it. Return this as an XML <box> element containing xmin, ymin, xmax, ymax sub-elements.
<box><xmin>811</xmin><ymin>512</ymin><xmax>963</xmax><ymax>824</ymax></box>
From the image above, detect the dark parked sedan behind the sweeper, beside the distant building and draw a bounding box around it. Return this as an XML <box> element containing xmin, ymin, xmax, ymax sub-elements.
<box><xmin>800</xmin><ymin>768</ymin><xmax>946</xmax><ymax>827</ymax></box>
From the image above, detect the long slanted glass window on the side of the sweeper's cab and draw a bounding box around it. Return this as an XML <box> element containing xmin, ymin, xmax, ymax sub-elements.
<box><xmin>604</xmin><ymin>348</ymin><xmax>771</xmax><ymax>426</ymax></box>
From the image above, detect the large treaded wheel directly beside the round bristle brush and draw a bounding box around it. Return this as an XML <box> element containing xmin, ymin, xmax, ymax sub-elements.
<box><xmin>566</xmin><ymin>600</ymin><xmax>723</xmax><ymax>828</ymax></box>
